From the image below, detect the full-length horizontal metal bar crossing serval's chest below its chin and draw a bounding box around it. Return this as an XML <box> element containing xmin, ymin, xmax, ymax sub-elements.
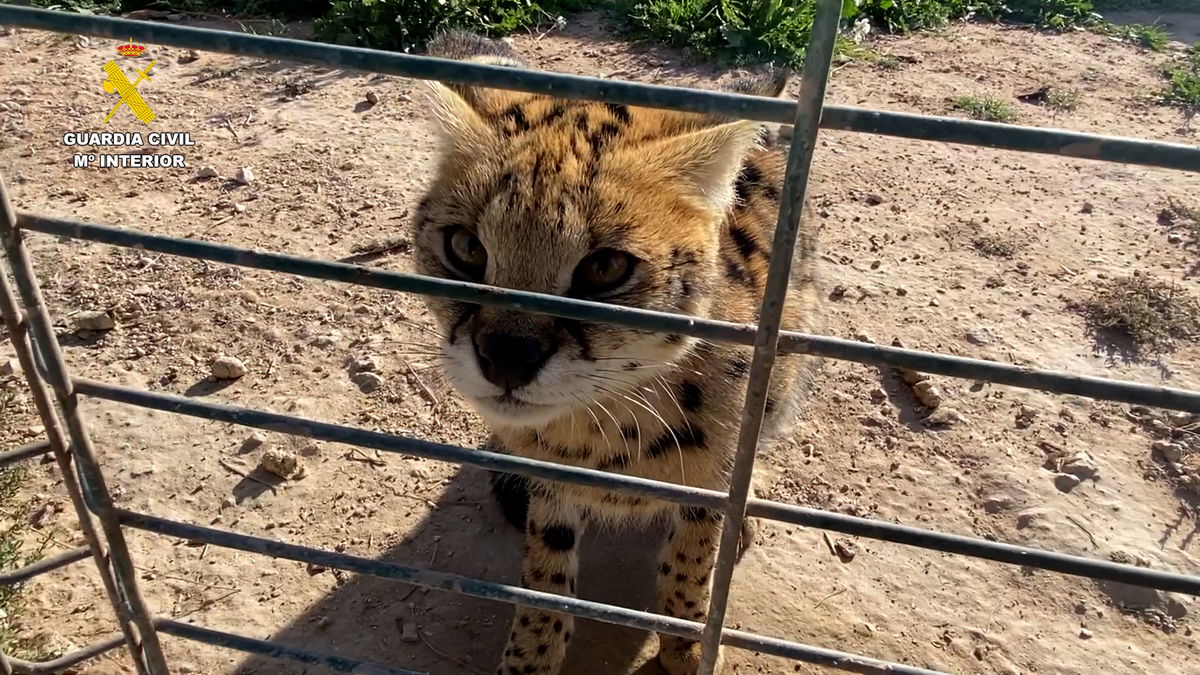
<box><xmin>74</xmin><ymin>378</ymin><xmax>1200</xmax><ymax>595</ymax></box>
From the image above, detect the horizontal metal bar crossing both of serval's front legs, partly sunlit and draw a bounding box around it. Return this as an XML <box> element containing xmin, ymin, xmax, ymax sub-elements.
<box><xmin>120</xmin><ymin>510</ymin><xmax>943</xmax><ymax>675</ymax></box>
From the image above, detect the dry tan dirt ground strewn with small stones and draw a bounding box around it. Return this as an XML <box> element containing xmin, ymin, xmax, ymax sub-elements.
<box><xmin>0</xmin><ymin>9</ymin><xmax>1200</xmax><ymax>675</ymax></box>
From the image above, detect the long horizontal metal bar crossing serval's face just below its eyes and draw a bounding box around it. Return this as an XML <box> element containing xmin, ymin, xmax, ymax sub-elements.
<box><xmin>18</xmin><ymin>214</ymin><xmax>1200</xmax><ymax>412</ymax></box>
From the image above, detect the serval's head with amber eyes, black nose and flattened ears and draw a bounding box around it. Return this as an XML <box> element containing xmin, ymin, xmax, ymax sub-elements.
<box><xmin>413</xmin><ymin>32</ymin><xmax>785</xmax><ymax>426</ymax></box>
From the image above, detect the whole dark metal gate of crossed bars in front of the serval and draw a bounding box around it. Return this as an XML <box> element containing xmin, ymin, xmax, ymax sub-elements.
<box><xmin>0</xmin><ymin>0</ymin><xmax>1200</xmax><ymax>675</ymax></box>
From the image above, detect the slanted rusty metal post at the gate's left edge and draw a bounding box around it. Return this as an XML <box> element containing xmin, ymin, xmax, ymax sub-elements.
<box><xmin>0</xmin><ymin>170</ymin><xmax>169</xmax><ymax>675</ymax></box>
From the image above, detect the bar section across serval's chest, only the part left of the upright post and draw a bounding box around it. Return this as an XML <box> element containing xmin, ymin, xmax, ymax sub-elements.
<box><xmin>73</xmin><ymin>378</ymin><xmax>726</xmax><ymax>509</ymax></box>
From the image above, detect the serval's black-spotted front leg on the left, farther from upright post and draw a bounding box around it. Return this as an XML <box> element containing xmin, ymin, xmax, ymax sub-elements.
<box><xmin>497</xmin><ymin>482</ymin><xmax>583</xmax><ymax>675</ymax></box>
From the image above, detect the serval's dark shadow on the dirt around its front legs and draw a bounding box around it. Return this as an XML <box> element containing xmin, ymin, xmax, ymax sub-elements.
<box><xmin>234</xmin><ymin>467</ymin><xmax>661</xmax><ymax>675</ymax></box>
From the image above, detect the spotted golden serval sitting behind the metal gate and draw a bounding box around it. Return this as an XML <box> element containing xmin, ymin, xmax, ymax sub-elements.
<box><xmin>413</xmin><ymin>32</ymin><xmax>816</xmax><ymax>675</ymax></box>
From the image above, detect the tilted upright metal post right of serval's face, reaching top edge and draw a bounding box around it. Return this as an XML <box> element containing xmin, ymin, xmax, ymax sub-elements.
<box><xmin>700</xmin><ymin>0</ymin><xmax>842</xmax><ymax>675</ymax></box>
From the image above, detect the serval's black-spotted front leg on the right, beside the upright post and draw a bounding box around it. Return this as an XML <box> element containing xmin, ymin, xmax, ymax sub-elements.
<box><xmin>658</xmin><ymin>507</ymin><xmax>721</xmax><ymax>675</ymax></box>
